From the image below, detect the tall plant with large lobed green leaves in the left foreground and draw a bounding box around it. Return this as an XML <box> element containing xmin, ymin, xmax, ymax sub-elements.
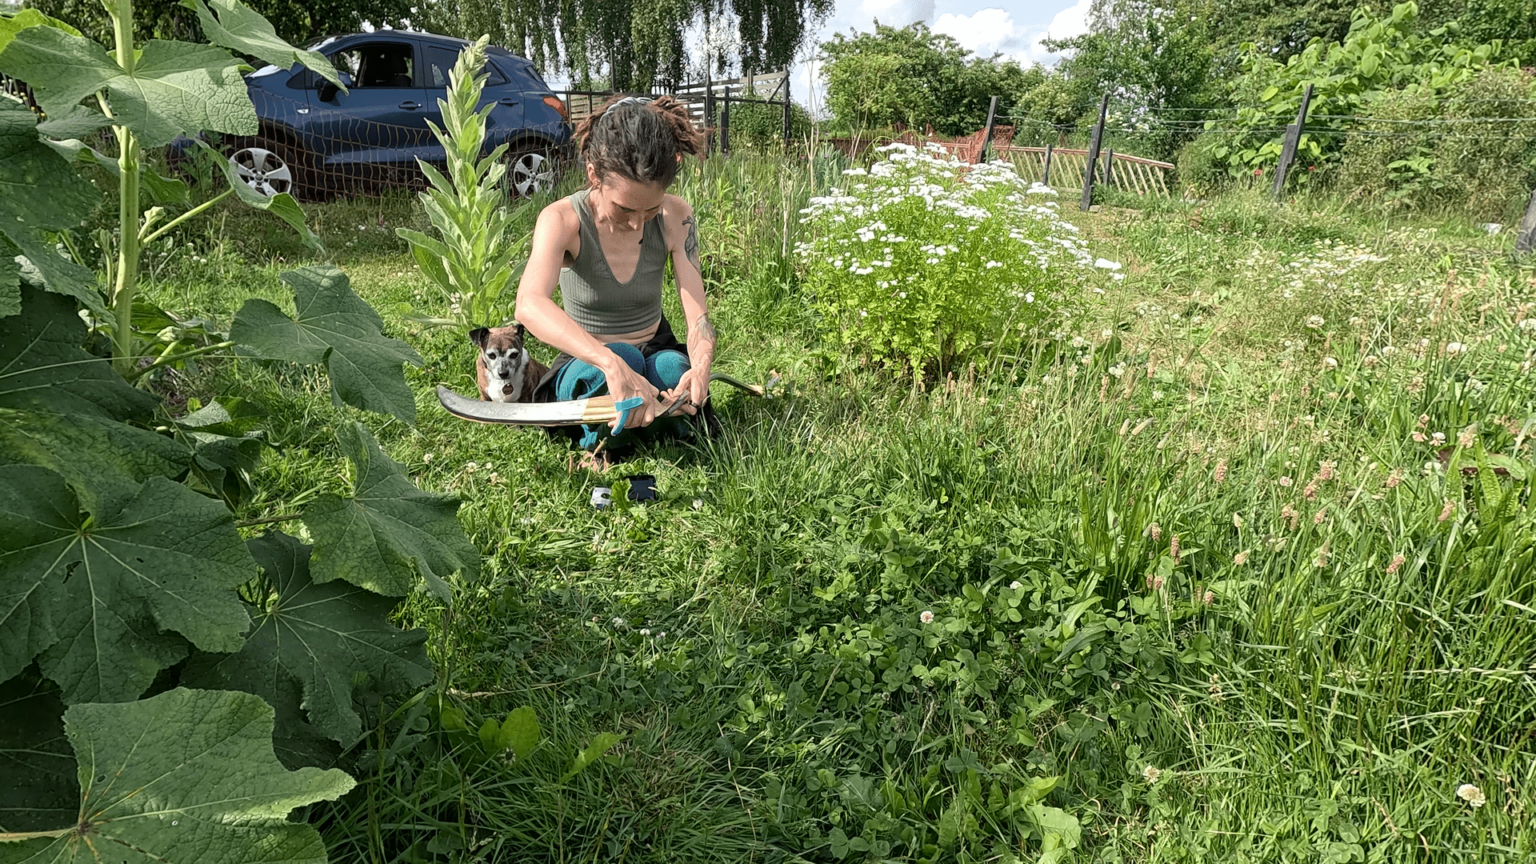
<box><xmin>0</xmin><ymin>0</ymin><xmax>479</xmax><ymax>862</ymax></box>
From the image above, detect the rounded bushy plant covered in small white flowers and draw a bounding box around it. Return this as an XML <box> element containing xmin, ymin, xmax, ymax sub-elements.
<box><xmin>796</xmin><ymin>145</ymin><xmax>1118</xmax><ymax>377</ymax></box>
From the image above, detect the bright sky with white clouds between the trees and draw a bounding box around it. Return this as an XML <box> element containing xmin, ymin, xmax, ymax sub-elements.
<box><xmin>793</xmin><ymin>0</ymin><xmax>1089</xmax><ymax>109</ymax></box>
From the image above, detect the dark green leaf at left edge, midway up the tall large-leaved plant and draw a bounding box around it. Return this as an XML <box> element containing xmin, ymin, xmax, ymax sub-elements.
<box><xmin>0</xmin><ymin>286</ymin><xmax>190</xmax><ymax>503</ymax></box>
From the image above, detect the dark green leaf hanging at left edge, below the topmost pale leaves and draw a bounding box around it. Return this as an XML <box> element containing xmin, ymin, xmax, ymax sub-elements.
<box><xmin>0</xmin><ymin>99</ymin><xmax>104</xmax><ymax>311</ymax></box>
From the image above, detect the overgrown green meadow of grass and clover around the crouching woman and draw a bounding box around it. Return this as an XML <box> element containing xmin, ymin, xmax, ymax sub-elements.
<box><xmin>81</xmin><ymin>157</ymin><xmax>1536</xmax><ymax>862</ymax></box>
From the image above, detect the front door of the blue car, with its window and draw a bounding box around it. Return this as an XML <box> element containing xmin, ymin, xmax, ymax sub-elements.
<box><xmin>306</xmin><ymin>37</ymin><xmax>436</xmax><ymax>169</ymax></box>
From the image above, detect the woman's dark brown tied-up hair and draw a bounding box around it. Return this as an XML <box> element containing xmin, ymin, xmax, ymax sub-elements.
<box><xmin>576</xmin><ymin>95</ymin><xmax>703</xmax><ymax>188</ymax></box>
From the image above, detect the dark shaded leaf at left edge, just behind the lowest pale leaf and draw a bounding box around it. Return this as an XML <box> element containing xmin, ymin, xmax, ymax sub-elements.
<box><xmin>0</xmin><ymin>670</ymin><xmax>80</xmax><ymax>832</ymax></box>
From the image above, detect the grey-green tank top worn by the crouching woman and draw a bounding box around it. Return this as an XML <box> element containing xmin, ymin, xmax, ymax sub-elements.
<box><xmin>561</xmin><ymin>189</ymin><xmax>667</xmax><ymax>334</ymax></box>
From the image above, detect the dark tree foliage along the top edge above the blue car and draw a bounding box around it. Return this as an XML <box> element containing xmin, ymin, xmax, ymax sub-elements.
<box><xmin>23</xmin><ymin>0</ymin><xmax>412</xmax><ymax>45</ymax></box>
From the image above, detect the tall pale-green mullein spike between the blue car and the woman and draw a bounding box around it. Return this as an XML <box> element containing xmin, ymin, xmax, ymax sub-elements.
<box><xmin>396</xmin><ymin>35</ymin><xmax>525</xmax><ymax>327</ymax></box>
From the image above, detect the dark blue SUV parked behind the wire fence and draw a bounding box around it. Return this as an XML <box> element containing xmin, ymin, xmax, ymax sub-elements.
<box><xmin>213</xmin><ymin>31</ymin><xmax>573</xmax><ymax>198</ymax></box>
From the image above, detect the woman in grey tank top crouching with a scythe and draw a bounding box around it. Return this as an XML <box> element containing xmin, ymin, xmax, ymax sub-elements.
<box><xmin>516</xmin><ymin>95</ymin><xmax>714</xmax><ymax>450</ymax></box>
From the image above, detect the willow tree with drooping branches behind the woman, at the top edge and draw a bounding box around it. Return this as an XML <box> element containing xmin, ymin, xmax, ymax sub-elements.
<box><xmin>418</xmin><ymin>0</ymin><xmax>834</xmax><ymax>91</ymax></box>
